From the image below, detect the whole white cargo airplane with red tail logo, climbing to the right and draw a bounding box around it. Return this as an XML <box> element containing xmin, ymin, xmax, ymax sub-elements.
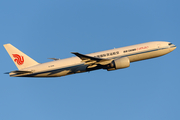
<box><xmin>4</xmin><ymin>41</ymin><xmax>176</xmax><ymax>77</ymax></box>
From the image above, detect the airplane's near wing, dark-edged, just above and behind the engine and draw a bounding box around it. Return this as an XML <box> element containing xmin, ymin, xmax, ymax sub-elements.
<box><xmin>71</xmin><ymin>52</ymin><xmax>112</xmax><ymax>67</ymax></box>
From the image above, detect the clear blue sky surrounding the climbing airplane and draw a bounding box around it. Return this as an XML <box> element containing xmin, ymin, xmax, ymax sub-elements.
<box><xmin>0</xmin><ymin>0</ymin><xmax>180</xmax><ymax>120</ymax></box>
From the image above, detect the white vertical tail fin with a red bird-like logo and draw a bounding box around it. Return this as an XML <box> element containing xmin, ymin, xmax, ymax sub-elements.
<box><xmin>4</xmin><ymin>44</ymin><xmax>39</xmax><ymax>70</ymax></box>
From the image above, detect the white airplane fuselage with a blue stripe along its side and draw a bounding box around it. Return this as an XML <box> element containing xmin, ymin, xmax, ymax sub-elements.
<box><xmin>10</xmin><ymin>41</ymin><xmax>176</xmax><ymax>77</ymax></box>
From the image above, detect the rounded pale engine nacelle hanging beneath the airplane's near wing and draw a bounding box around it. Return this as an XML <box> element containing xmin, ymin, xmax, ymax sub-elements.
<box><xmin>107</xmin><ymin>57</ymin><xmax>130</xmax><ymax>71</ymax></box>
